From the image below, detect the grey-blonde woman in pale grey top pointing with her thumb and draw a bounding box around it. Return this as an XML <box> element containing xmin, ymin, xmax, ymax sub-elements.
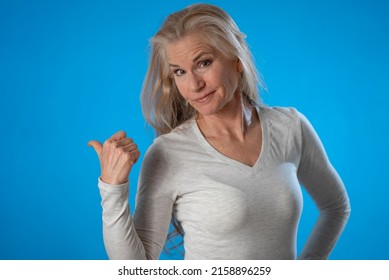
<box><xmin>89</xmin><ymin>4</ymin><xmax>350</xmax><ymax>259</ymax></box>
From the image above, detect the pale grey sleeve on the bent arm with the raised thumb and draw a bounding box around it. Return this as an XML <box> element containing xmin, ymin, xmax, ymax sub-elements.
<box><xmin>98</xmin><ymin>140</ymin><xmax>174</xmax><ymax>260</ymax></box>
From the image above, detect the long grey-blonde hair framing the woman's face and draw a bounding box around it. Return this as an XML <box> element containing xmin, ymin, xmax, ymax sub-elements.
<box><xmin>141</xmin><ymin>4</ymin><xmax>262</xmax><ymax>135</ymax></box>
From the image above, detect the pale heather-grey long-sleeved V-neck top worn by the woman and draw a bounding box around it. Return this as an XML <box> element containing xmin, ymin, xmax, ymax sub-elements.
<box><xmin>98</xmin><ymin>107</ymin><xmax>350</xmax><ymax>259</ymax></box>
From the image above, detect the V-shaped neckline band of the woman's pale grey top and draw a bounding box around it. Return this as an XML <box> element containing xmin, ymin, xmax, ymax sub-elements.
<box><xmin>191</xmin><ymin>106</ymin><xmax>269</xmax><ymax>174</ymax></box>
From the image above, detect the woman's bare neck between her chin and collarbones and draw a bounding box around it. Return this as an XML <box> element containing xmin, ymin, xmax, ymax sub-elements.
<box><xmin>197</xmin><ymin>93</ymin><xmax>256</xmax><ymax>141</ymax></box>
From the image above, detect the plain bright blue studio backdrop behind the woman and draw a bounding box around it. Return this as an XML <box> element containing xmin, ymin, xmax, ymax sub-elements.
<box><xmin>0</xmin><ymin>0</ymin><xmax>389</xmax><ymax>259</ymax></box>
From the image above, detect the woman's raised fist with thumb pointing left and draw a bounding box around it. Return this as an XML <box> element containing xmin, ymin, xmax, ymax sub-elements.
<box><xmin>88</xmin><ymin>131</ymin><xmax>140</xmax><ymax>185</ymax></box>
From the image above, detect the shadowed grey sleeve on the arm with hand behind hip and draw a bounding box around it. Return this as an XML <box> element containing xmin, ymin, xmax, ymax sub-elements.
<box><xmin>297</xmin><ymin>110</ymin><xmax>350</xmax><ymax>259</ymax></box>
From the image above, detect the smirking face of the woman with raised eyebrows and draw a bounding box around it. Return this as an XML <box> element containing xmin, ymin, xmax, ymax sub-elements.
<box><xmin>166</xmin><ymin>34</ymin><xmax>242</xmax><ymax>115</ymax></box>
